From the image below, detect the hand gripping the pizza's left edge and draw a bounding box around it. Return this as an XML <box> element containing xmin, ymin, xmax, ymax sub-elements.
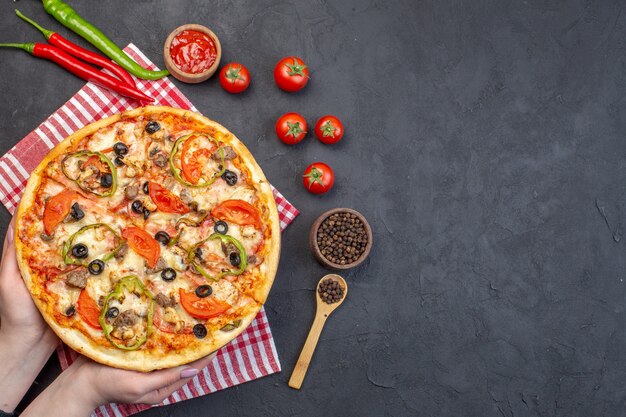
<box><xmin>0</xmin><ymin>216</ymin><xmax>58</xmax><ymax>412</ymax></box>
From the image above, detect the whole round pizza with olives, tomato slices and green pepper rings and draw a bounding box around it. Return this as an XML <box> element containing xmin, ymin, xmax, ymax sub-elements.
<box><xmin>15</xmin><ymin>106</ymin><xmax>280</xmax><ymax>371</ymax></box>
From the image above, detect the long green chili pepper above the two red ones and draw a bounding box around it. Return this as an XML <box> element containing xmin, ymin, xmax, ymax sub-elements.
<box><xmin>43</xmin><ymin>0</ymin><xmax>169</xmax><ymax>80</ymax></box>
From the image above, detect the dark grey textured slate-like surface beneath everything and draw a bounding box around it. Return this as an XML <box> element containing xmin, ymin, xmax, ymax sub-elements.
<box><xmin>0</xmin><ymin>0</ymin><xmax>626</xmax><ymax>417</ymax></box>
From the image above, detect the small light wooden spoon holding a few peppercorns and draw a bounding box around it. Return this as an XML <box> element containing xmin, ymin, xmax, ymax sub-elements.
<box><xmin>289</xmin><ymin>274</ymin><xmax>348</xmax><ymax>389</ymax></box>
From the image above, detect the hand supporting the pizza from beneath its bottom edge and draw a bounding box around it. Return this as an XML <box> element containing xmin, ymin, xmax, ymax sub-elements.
<box><xmin>22</xmin><ymin>354</ymin><xmax>215</xmax><ymax>417</ymax></box>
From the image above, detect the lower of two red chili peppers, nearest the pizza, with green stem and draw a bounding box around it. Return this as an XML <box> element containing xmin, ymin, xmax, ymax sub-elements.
<box><xmin>0</xmin><ymin>43</ymin><xmax>154</xmax><ymax>102</ymax></box>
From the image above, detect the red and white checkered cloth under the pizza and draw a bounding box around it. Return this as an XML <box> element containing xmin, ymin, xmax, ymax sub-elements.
<box><xmin>0</xmin><ymin>44</ymin><xmax>299</xmax><ymax>417</ymax></box>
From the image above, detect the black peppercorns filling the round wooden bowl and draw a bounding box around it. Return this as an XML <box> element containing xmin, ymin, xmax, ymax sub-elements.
<box><xmin>317</xmin><ymin>213</ymin><xmax>367</xmax><ymax>265</ymax></box>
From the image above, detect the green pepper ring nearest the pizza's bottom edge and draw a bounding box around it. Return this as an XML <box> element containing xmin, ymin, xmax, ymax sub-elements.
<box><xmin>100</xmin><ymin>275</ymin><xmax>154</xmax><ymax>350</ymax></box>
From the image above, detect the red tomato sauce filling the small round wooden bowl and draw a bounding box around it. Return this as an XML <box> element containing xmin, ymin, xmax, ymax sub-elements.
<box><xmin>170</xmin><ymin>30</ymin><xmax>217</xmax><ymax>74</ymax></box>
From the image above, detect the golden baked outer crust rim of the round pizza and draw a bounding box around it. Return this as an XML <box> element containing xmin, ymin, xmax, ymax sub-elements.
<box><xmin>14</xmin><ymin>106</ymin><xmax>280</xmax><ymax>372</ymax></box>
